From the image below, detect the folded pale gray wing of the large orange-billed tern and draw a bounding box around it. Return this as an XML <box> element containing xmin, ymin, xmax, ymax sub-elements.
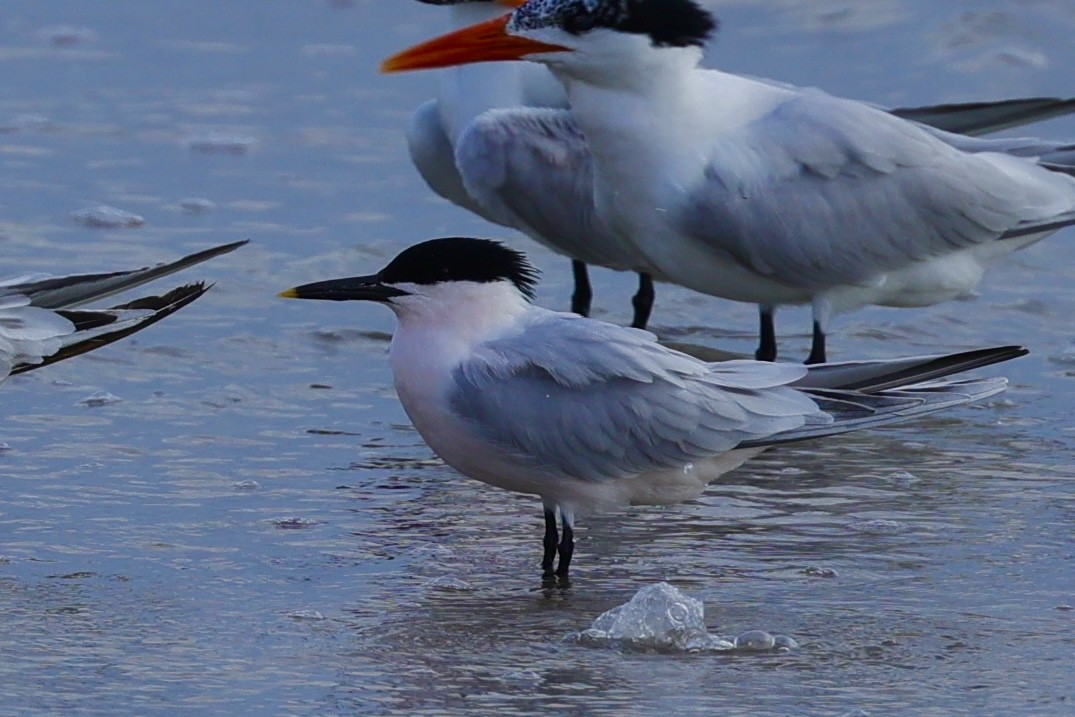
<box><xmin>675</xmin><ymin>91</ymin><xmax>1075</xmax><ymax>290</ymax></box>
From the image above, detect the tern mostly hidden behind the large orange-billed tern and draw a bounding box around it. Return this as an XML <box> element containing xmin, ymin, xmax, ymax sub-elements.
<box><xmin>406</xmin><ymin>0</ymin><xmax>1075</xmax><ymax>329</ymax></box>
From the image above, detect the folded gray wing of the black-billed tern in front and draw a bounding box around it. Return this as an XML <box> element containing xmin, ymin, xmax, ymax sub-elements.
<box><xmin>449</xmin><ymin>313</ymin><xmax>825</xmax><ymax>481</ymax></box>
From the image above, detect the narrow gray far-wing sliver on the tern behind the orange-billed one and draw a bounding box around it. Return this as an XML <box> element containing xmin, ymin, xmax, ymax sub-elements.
<box><xmin>406</xmin><ymin>100</ymin><xmax>511</xmax><ymax>226</ymax></box>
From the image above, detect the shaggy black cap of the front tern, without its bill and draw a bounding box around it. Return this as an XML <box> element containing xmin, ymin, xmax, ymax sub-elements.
<box><xmin>379</xmin><ymin>236</ymin><xmax>539</xmax><ymax>299</ymax></box>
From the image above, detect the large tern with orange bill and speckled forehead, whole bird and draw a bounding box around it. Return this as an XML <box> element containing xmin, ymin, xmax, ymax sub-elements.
<box><xmin>383</xmin><ymin>0</ymin><xmax>1075</xmax><ymax>363</ymax></box>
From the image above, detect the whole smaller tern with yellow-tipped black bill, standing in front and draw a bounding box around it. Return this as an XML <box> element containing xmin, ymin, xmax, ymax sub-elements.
<box><xmin>281</xmin><ymin>239</ymin><xmax>1027</xmax><ymax>575</ymax></box>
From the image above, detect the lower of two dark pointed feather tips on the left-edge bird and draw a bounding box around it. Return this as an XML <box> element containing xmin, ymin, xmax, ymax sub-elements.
<box><xmin>7</xmin><ymin>283</ymin><xmax>212</xmax><ymax>374</ymax></box>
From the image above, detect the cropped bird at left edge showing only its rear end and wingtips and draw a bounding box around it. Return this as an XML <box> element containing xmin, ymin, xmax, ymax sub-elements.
<box><xmin>0</xmin><ymin>241</ymin><xmax>246</xmax><ymax>382</ymax></box>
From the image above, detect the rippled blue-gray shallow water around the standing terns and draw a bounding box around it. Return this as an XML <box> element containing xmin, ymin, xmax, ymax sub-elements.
<box><xmin>0</xmin><ymin>0</ymin><xmax>1075</xmax><ymax>715</ymax></box>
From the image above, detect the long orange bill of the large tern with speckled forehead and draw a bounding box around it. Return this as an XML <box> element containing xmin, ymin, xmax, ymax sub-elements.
<box><xmin>381</xmin><ymin>15</ymin><xmax>569</xmax><ymax>72</ymax></box>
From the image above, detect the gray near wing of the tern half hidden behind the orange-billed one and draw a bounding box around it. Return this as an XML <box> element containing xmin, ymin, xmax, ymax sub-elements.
<box><xmin>456</xmin><ymin>107</ymin><xmax>633</xmax><ymax>270</ymax></box>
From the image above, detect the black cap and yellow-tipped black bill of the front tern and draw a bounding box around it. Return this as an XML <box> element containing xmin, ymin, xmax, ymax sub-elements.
<box><xmin>280</xmin><ymin>236</ymin><xmax>538</xmax><ymax>303</ymax></box>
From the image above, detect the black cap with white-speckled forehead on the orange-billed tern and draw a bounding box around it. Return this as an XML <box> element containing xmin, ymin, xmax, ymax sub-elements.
<box><xmin>508</xmin><ymin>0</ymin><xmax>717</xmax><ymax>47</ymax></box>
